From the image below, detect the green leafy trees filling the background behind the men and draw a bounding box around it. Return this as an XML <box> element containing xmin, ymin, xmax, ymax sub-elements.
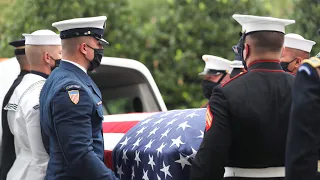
<box><xmin>0</xmin><ymin>0</ymin><xmax>312</xmax><ymax>109</ymax></box>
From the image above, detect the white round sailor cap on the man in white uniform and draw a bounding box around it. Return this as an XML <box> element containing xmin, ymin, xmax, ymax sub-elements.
<box><xmin>22</xmin><ymin>29</ymin><xmax>61</xmax><ymax>46</ymax></box>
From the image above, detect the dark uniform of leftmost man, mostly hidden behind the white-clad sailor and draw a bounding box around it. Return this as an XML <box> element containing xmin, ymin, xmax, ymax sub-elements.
<box><xmin>0</xmin><ymin>70</ymin><xmax>29</xmax><ymax>180</ymax></box>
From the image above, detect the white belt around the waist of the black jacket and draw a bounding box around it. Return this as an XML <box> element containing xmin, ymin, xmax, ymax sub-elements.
<box><xmin>224</xmin><ymin>167</ymin><xmax>285</xmax><ymax>178</ymax></box>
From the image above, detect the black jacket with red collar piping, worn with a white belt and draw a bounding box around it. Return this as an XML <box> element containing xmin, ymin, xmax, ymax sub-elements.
<box><xmin>190</xmin><ymin>60</ymin><xmax>294</xmax><ymax>180</ymax></box>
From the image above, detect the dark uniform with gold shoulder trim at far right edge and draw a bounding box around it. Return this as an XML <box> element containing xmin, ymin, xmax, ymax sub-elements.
<box><xmin>286</xmin><ymin>56</ymin><xmax>320</xmax><ymax>180</ymax></box>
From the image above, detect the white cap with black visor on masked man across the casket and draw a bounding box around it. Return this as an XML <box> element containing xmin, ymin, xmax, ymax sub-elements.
<box><xmin>199</xmin><ymin>55</ymin><xmax>231</xmax><ymax>75</ymax></box>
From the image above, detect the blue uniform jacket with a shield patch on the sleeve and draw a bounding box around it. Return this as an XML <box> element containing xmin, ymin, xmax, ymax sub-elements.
<box><xmin>40</xmin><ymin>61</ymin><xmax>117</xmax><ymax>180</ymax></box>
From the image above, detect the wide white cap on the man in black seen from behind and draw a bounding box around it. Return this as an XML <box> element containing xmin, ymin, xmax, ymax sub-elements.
<box><xmin>232</xmin><ymin>14</ymin><xmax>295</xmax><ymax>33</ymax></box>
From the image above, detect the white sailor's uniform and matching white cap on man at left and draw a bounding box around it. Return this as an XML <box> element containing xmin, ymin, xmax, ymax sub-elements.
<box><xmin>4</xmin><ymin>30</ymin><xmax>61</xmax><ymax>180</ymax></box>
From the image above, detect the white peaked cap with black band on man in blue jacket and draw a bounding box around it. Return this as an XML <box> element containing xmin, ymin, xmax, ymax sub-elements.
<box><xmin>52</xmin><ymin>16</ymin><xmax>109</xmax><ymax>45</ymax></box>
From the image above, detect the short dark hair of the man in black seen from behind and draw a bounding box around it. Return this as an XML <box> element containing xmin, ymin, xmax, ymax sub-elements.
<box><xmin>246</xmin><ymin>31</ymin><xmax>284</xmax><ymax>53</ymax></box>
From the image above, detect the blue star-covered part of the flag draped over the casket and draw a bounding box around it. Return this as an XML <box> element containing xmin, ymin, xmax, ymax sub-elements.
<box><xmin>113</xmin><ymin>109</ymin><xmax>206</xmax><ymax>180</ymax></box>
